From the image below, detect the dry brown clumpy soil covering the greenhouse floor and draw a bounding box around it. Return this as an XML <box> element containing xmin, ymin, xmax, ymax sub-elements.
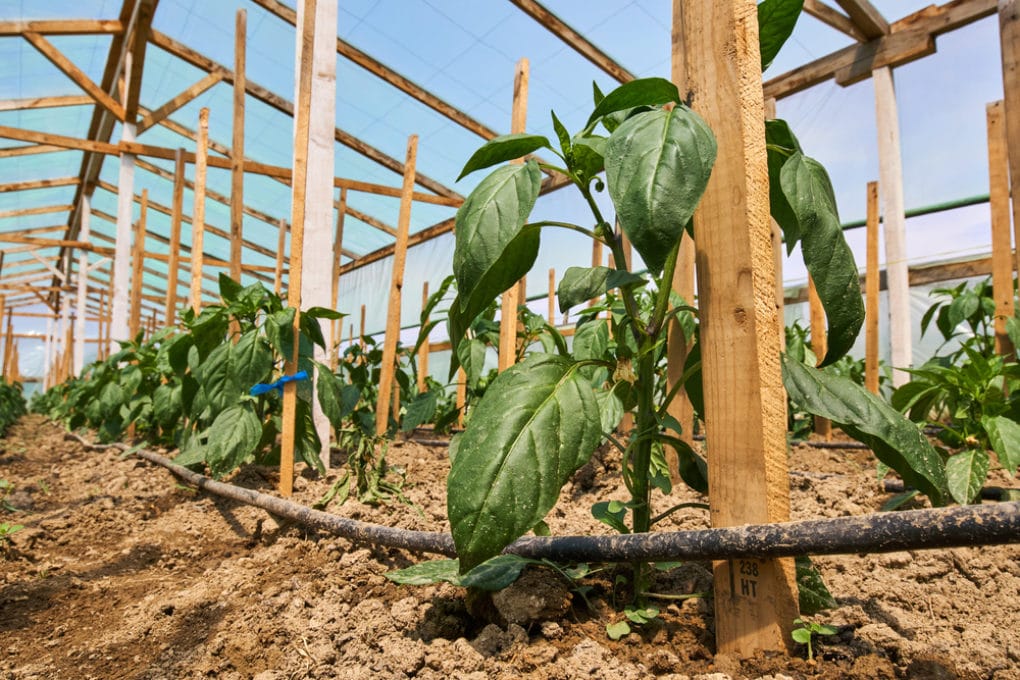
<box><xmin>0</xmin><ymin>416</ymin><xmax>1020</xmax><ymax>680</ymax></box>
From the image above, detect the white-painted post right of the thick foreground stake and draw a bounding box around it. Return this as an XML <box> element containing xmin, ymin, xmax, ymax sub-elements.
<box><xmin>871</xmin><ymin>66</ymin><xmax>913</xmax><ymax>387</ymax></box>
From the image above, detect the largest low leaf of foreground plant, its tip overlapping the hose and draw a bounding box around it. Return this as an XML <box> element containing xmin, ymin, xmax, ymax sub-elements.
<box><xmin>447</xmin><ymin>354</ymin><xmax>602</xmax><ymax>573</ymax></box>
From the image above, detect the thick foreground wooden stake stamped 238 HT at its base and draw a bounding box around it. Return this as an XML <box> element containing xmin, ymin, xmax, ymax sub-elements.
<box><xmin>674</xmin><ymin>0</ymin><xmax>798</xmax><ymax>657</ymax></box>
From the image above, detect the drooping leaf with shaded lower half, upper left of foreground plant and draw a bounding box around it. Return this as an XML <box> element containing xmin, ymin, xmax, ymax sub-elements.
<box><xmin>451</xmin><ymin>160</ymin><xmax>542</xmax><ymax>345</ymax></box>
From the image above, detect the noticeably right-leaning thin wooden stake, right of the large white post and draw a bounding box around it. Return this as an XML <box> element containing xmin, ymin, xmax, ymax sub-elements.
<box><xmin>375</xmin><ymin>135</ymin><xmax>418</xmax><ymax>436</ymax></box>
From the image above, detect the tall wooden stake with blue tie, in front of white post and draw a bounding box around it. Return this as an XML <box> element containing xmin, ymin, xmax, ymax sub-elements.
<box><xmin>279</xmin><ymin>0</ymin><xmax>316</xmax><ymax>498</ymax></box>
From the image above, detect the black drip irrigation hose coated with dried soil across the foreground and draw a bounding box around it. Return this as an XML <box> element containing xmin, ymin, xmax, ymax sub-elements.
<box><xmin>72</xmin><ymin>435</ymin><xmax>1020</xmax><ymax>562</ymax></box>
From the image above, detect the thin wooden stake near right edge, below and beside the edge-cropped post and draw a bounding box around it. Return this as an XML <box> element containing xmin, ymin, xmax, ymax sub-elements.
<box><xmin>985</xmin><ymin>101</ymin><xmax>1020</xmax><ymax>357</ymax></box>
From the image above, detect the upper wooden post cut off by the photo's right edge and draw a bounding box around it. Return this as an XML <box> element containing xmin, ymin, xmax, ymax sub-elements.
<box><xmin>999</xmin><ymin>0</ymin><xmax>1020</xmax><ymax>279</ymax></box>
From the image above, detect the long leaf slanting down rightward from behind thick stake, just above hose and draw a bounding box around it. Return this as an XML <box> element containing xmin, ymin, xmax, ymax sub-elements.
<box><xmin>782</xmin><ymin>356</ymin><xmax>947</xmax><ymax>506</ymax></box>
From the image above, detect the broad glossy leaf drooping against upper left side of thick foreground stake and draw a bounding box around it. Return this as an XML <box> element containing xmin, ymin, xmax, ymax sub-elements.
<box><xmin>603</xmin><ymin>107</ymin><xmax>716</xmax><ymax>273</ymax></box>
